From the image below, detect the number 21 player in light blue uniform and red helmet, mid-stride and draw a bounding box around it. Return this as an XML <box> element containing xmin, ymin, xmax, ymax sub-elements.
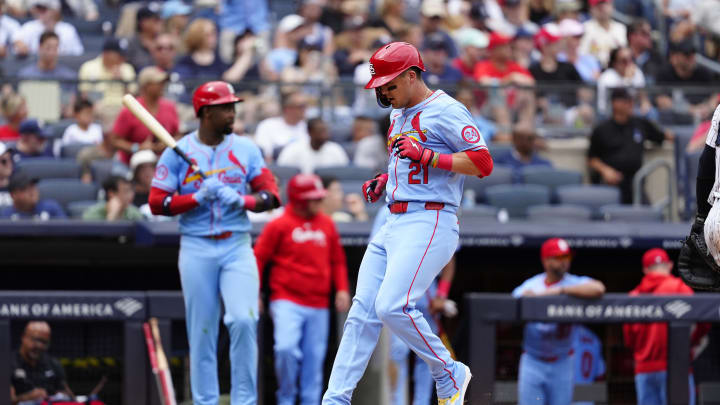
<box><xmin>322</xmin><ymin>42</ymin><xmax>492</xmax><ymax>405</ymax></box>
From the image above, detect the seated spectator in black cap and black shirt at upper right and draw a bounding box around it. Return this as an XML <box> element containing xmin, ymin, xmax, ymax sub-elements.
<box><xmin>655</xmin><ymin>39</ymin><xmax>716</xmax><ymax>121</ymax></box>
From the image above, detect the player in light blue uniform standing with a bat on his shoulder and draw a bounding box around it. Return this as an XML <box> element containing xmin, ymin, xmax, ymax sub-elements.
<box><xmin>146</xmin><ymin>81</ymin><xmax>280</xmax><ymax>405</ymax></box>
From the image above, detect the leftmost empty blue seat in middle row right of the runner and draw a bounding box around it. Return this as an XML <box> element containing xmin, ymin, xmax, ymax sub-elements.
<box><xmin>485</xmin><ymin>185</ymin><xmax>550</xmax><ymax>218</ymax></box>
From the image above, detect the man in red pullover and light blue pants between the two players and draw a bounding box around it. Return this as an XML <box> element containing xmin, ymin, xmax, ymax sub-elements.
<box><xmin>255</xmin><ymin>174</ymin><xmax>350</xmax><ymax>405</ymax></box>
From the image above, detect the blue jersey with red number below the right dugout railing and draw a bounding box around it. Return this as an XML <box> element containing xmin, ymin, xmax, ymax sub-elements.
<box><xmin>572</xmin><ymin>325</ymin><xmax>605</xmax><ymax>384</ymax></box>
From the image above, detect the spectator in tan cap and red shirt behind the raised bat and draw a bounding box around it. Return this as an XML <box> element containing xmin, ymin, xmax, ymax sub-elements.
<box><xmin>111</xmin><ymin>66</ymin><xmax>180</xmax><ymax>164</ymax></box>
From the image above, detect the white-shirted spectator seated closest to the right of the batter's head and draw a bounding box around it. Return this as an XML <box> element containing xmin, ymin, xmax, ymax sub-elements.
<box><xmin>255</xmin><ymin>92</ymin><xmax>308</xmax><ymax>163</ymax></box>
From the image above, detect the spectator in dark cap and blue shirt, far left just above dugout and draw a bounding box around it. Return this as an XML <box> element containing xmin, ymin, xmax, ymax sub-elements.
<box><xmin>0</xmin><ymin>170</ymin><xmax>67</xmax><ymax>221</ymax></box>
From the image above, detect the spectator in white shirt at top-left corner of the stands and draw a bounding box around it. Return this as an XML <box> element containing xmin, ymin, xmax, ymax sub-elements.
<box><xmin>13</xmin><ymin>0</ymin><xmax>85</xmax><ymax>57</ymax></box>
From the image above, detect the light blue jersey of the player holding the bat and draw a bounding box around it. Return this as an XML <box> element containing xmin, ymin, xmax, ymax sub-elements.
<box><xmin>152</xmin><ymin>131</ymin><xmax>265</xmax><ymax>236</ymax></box>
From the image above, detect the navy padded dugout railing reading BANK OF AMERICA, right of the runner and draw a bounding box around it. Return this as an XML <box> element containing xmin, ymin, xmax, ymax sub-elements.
<box><xmin>465</xmin><ymin>293</ymin><xmax>720</xmax><ymax>405</ymax></box>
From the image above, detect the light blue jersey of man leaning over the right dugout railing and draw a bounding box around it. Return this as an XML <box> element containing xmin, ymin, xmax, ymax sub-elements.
<box><xmin>512</xmin><ymin>273</ymin><xmax>592</xmax><ymax>358</ymax></box>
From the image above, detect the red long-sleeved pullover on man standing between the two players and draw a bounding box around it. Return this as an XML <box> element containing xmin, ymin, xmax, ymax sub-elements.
<box><xmin>255</xmin><ymin>205</ymin><xmax>348</xmax><ymax>308</ymax></box>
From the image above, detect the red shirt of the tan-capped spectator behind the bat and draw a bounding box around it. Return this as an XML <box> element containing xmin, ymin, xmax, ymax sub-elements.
<box><xmin>113</xmin><ymin>97</ymin><xmax>180</xmax><ymax>164</ymax></box>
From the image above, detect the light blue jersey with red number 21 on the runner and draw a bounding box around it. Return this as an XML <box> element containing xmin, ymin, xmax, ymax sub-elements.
<box><xmin>385</xmin><ymin>90</ymin><xmax>487</xmax><ymax>207</ymax></box>
